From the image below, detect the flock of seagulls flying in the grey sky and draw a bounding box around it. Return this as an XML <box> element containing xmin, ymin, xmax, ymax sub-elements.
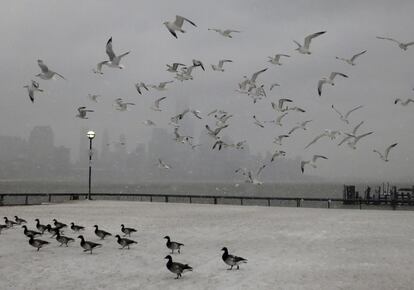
<box><xmin>24</xmin><ymin>15</ymin><xmax>414</xmax><ymax>185</ymax></box>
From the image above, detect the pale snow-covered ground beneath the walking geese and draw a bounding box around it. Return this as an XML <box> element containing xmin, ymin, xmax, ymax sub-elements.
<box><xmin>0</xmin><ymin>201</ymin><xmax>414</xmax><ymax>290</ymax></box>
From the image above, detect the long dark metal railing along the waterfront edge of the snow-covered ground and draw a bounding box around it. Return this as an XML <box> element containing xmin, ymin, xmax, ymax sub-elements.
<box><xmin>0</xmin><ymin>193</ymin><xmax>414</xmax><ymax>209</ymax></box>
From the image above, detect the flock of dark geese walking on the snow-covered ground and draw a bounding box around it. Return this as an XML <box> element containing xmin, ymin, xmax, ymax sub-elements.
<box><xmin>0</xmin><ymin>216</ymin><xmax>247</xmax><ymax>279</ymax></box>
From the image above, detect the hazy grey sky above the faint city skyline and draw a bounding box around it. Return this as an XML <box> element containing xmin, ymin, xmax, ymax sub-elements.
<box><xmin>0</xmin><ymin>0</ymin><xmax>414</xmax><ymax>180</ymax></box>
